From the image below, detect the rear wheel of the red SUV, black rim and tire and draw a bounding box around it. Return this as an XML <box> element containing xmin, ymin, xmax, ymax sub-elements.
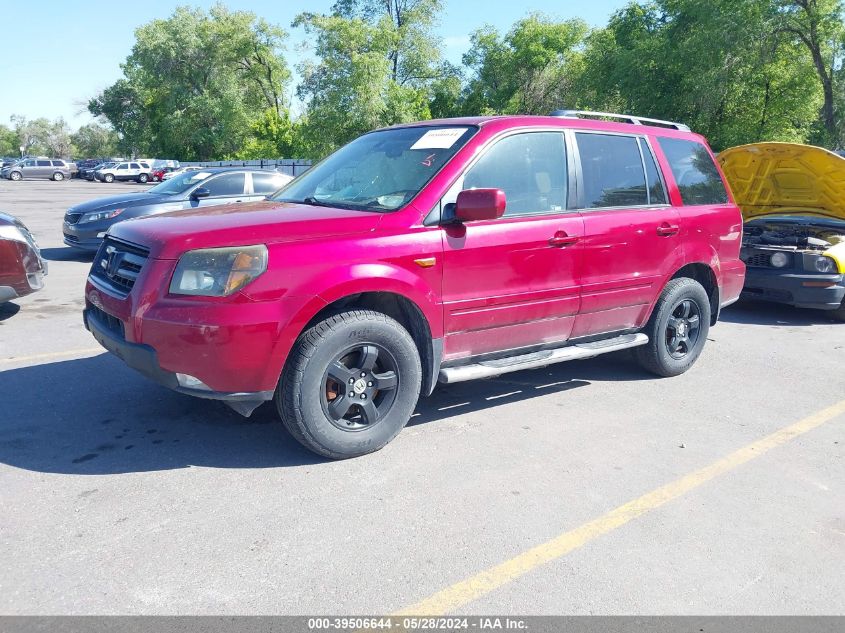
<box><xmin>634</xmin><ymin>277</ymin><xmax>710</xmax><ymax>377</ymax></box>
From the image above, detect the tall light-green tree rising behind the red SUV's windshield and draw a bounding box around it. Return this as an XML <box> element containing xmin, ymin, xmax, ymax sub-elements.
<box><xmin>294</xmin><ymin>0</ymin><xmax>454</xmax><ymax>157</ymax></box>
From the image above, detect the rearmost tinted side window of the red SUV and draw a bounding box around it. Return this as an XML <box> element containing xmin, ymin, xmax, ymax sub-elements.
<box><xmin>658</xmin><ymin>138</ymin><xmax>728</xmax><ymax>205</ymax></box>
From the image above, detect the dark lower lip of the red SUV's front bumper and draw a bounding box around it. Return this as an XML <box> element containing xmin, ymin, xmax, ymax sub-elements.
<box><xmin>82</xmin><ymin>307</ymin><xmax>273</xmax><ymax>416</ymax></box>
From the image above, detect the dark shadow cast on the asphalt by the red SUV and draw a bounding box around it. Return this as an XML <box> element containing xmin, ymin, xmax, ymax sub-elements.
<box><xmin>0</xmin><ymin>354</ymin><xmax>651</xmax><ymax>475</ymax></box>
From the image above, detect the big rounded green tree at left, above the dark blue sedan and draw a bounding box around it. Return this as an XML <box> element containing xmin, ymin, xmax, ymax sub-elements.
<box><xmin>88</xmin><ymin>4</ymin><xmax>290</xmax><ymax>160</ymax></box>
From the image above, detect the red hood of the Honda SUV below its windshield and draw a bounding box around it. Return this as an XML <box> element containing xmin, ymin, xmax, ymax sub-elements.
<box><xmin>109</xmin><ymin>200</ymin><xmax>383</xmax><ymax>259</ymax></box>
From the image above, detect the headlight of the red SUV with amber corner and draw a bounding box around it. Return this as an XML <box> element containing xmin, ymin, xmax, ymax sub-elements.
<box><xmin>170</xmin><ymin>244</ymin><xmax>267</xmax><ymax>297</ymax></box>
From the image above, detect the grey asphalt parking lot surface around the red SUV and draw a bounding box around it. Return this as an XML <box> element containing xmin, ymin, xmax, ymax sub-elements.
<box><xmin>0</xmin><ymin>180</ymin><xmax>845</xmax><ymax>615</ymax></box>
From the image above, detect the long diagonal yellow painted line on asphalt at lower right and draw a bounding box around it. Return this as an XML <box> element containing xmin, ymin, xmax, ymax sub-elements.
<box><xmin>397</xmin><ymin>400</ymin><xmax>845</xmax><ymax>615</ymax></box>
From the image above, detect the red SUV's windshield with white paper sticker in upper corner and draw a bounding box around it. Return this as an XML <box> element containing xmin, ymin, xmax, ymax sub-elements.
<box><xmin>273</xmin><ymin>126</ymin><xmax>477</xmax><ymax>211</ymax></box>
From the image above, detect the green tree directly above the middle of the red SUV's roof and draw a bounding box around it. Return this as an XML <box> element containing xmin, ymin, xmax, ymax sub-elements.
<box><xmin>463</xmin><ymin>14</ymin><xmax>588</xmax><ymax>114</ymax></box>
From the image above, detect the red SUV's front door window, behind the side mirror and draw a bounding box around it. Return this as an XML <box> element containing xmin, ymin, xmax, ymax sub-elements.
<box><xmin>449</xmin><ymin>132</ymin><xmax>568</xmax><ymax>216</ymax></box>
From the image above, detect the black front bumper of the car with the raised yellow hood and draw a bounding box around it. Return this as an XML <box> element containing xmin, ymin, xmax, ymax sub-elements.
<box><xmin>742</xmin><ymin>268</ymin><xmax>845</xmax><ymax>310</ymax></box>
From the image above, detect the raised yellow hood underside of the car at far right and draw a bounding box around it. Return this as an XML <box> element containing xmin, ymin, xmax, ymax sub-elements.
<box><xmin>718</xmin><ymin>143</ymin><xmax>845</xmax><ymax>220</ymax></box>
